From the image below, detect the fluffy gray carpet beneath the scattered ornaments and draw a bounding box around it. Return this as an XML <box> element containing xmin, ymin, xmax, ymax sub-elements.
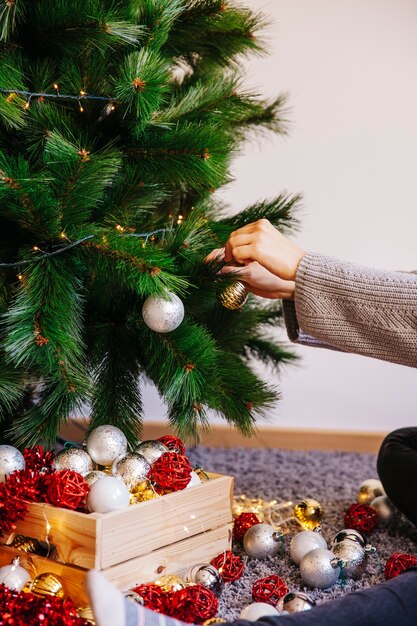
<box><xmin>187</xmin><ymin>447</ymin><xmax>417</xmax><ymax>620</ymax></box>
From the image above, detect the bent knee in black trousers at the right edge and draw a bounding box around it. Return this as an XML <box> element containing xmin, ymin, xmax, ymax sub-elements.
<box><xmin>377</xmin><ymin>427</ymin><xmax>417</xmax><ymax>526</ymax></box>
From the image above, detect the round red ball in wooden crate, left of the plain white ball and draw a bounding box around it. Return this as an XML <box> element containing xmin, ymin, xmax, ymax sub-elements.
<box><xmin>46</xmin><ymin>470</ymin><xmax>90</xmax><ymax>509</ymax></box>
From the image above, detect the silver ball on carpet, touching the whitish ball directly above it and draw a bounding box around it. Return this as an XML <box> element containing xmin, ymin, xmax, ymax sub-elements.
<box><xmin>300</xmin><ymin>544</ymin><xmax>340</xmax><ymax>589</ymax></box>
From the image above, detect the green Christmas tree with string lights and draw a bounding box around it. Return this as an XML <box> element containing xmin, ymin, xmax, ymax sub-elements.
<box><xmin>0</xmin><ymin>0</ymin><xmax>298</xmax><ymax>446</ymax></box>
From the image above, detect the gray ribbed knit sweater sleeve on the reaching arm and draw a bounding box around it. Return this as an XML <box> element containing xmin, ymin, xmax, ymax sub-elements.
<box><xmin>284</xmin><ymin>253</ymin><xmax>417</xmax><ymax>367</ymax></box>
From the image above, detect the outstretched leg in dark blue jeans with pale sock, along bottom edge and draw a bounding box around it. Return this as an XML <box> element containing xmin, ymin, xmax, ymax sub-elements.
<box><xmin>87</xmin><ymin>570</ymin><xmax>417</xmax><ymax>626</ymax></box>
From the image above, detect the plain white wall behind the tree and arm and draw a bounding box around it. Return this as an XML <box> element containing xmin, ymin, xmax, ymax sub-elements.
<box><xmin>146</xmin><ymin>0</ymin><xmax>417</xmax><ymax>431</ymax></box>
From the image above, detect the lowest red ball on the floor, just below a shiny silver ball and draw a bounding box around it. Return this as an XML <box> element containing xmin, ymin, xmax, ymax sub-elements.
<box><xmin>167</xmin><ymin>585</ymin><xmax>219</xmax><ymax>624</ymax></box>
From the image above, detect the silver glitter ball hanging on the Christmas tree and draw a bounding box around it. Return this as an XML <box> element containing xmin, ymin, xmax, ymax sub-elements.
<box><xmin>142</xmin><ymin>291</ymin><xmax>184</xmax><ymax>333</ymax></box>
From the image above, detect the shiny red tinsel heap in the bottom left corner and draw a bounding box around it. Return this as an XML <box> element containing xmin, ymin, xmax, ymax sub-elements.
<box><xmin>0</xmin><ymin>585</ymin><xmax>90</xmax><ymax>626</ymax></box>
